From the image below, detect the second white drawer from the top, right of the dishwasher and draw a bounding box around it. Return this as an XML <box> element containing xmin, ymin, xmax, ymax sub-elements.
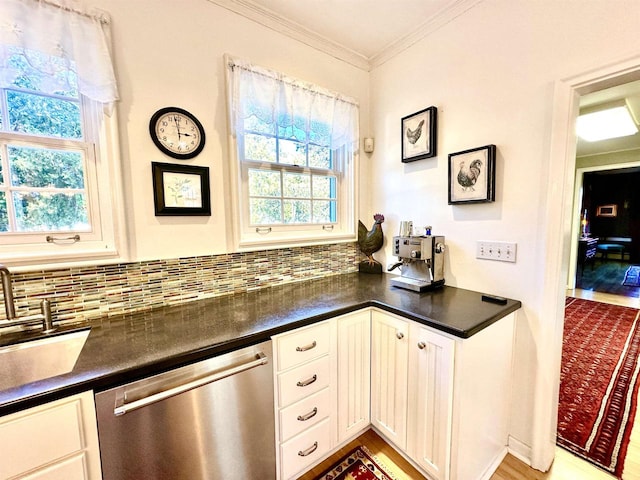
<box><xmin>278</xmin><ymin>355</ymin><xmax>329</xmax><ymax>407</ymax></box>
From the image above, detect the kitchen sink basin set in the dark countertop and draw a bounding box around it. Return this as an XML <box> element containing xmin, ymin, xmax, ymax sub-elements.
<box><xmin>0</xmin><ymin>328</ymin><xmax>90</xmax><ymax>391</ymax></box>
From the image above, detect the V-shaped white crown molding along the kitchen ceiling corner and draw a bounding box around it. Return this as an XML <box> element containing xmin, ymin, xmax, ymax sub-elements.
<box><xmin>207</xmin><ymin>0</ymin><xmax>483</xmax><ymax>72</ymax></box>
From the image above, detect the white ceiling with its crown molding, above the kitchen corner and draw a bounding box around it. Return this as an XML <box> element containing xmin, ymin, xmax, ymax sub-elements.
<box><xmin>209</xmin><ymin>0</ymin><xmax>482</xmax><ymax>70</ymax></box>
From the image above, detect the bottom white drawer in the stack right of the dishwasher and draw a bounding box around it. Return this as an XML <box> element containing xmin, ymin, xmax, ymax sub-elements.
<box><xmin>280</xmin><ymin>418</ymin><xmax>331</xmax><ymax>478</ymax></box>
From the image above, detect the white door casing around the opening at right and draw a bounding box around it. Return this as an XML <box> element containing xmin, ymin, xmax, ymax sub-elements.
<box><xmin>531</xmin><ymin>51</ymin><xmax>640</xmax><ymax>471</ymax></box>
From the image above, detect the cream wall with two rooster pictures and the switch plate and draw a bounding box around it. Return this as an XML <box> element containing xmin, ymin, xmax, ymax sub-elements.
<box><xmin>371</xmin><ymin>0</ymin><xmax>640</xmax><ymax>454</ymax></box>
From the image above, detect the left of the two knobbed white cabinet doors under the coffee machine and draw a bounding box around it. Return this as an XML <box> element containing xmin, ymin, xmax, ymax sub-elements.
<box><xmin>371</xmin><ymin>310</ymin><xmax>409</xmax><ymax>450</ymax></box>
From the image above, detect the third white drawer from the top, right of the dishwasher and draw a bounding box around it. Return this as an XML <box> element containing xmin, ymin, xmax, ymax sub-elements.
<box><xmin>279</xmin><ymin>388</ymin><xmax>331</xmax><ymax>441</ymax></box>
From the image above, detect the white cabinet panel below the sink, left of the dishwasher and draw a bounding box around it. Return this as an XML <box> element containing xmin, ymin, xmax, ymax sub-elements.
<box><xmin>0</xmin><ymin>399</ymin><xmax>84</xmax><ymax>478</ymax></box>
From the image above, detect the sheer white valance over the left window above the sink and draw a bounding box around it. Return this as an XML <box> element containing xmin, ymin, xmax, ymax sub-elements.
<box><xmin>0</xmin><ymin>0</ymin><xmax>118</xmax><ymax>105</ymax></box>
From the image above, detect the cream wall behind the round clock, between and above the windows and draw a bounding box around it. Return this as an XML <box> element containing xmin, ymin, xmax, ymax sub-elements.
<box><xmin>90</xmin><ymin>0</ymin><xmax>369</xmax><ymax>260</ymax></box>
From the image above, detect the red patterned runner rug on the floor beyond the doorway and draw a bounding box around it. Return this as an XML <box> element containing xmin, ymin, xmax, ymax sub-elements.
<box><xmin>557</xmin><ymin>297</ymin><xmax>640</xmax><ymax>478</ymax></box>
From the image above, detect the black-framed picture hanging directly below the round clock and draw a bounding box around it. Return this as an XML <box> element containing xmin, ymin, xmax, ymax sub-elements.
<box><xmin>151</xmin><ymin>162</ymin><xmax>211</xmax><ymax>216</ymax></box>
